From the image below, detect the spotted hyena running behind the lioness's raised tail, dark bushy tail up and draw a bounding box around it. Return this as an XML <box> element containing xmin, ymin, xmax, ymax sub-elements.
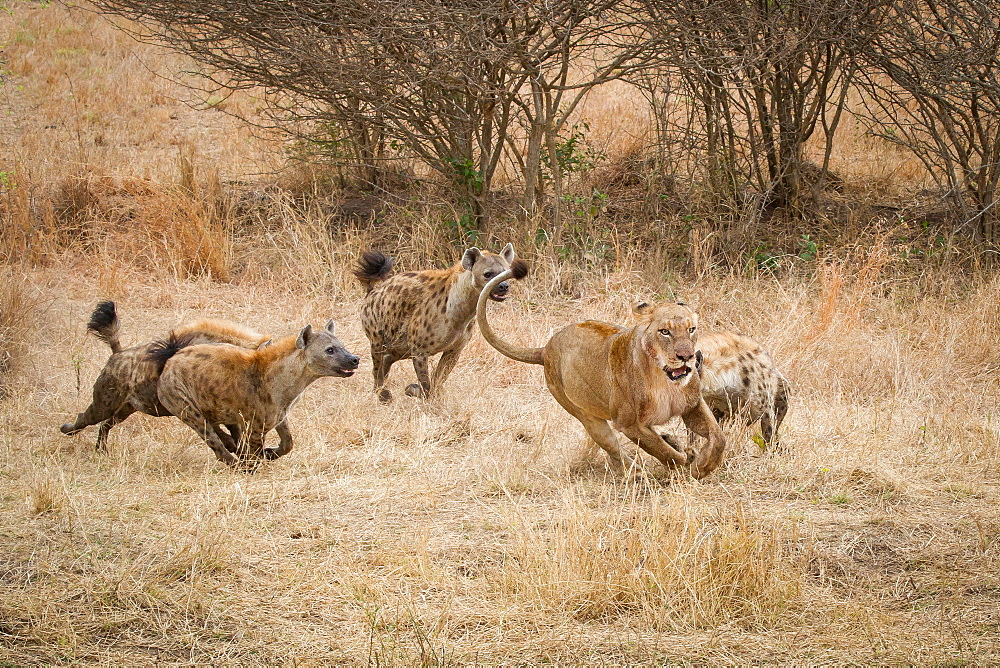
<box><xmin>354</xmin><ymin>244</ymin><xmax>514</xmax><ymax>401</ymax></box>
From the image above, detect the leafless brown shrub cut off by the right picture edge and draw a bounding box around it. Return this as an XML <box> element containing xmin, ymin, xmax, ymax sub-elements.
<box><xmin>864</xmin><ymin>0</ymin><xmax>1000</xmax><ymax>245</ymax></box>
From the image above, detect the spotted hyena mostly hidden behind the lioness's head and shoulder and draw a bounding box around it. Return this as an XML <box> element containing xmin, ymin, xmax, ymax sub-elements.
<box><xmin>698</xmin><ymin>331</ymin><xmax>789</xmax><ymax>447</ymax></box>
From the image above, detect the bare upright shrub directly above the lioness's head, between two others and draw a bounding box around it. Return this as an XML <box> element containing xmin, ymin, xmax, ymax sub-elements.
<box><xmin>637</xmin><ymin>0</ymin><xmax>881</xmax><ymax>223</ymax></box>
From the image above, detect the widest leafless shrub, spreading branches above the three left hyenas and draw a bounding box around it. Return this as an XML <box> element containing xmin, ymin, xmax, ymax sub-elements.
<box><xmin>84</xmin><ymin>0</ymin><xmax>646</xmax><ymax>229</ymax></box>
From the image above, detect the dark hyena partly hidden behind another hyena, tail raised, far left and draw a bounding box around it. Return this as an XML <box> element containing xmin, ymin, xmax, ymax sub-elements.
<box><xmin>60</xmin><ymin>301</ymin><xmax>270</xmax><ymax>450</ymax></box>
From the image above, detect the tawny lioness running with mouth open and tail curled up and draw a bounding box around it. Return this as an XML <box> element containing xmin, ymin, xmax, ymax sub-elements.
<box><xmin>476</xmin><ymin>260</ymin><xmax>726</xmax><ymax>479</ymax></box>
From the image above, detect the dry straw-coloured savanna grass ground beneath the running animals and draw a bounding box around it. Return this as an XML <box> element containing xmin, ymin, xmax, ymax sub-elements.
<box><xmin>0</xmin><ymin>2</ymin><xmax>1000</xmax><ymax>665</ymax></box>
